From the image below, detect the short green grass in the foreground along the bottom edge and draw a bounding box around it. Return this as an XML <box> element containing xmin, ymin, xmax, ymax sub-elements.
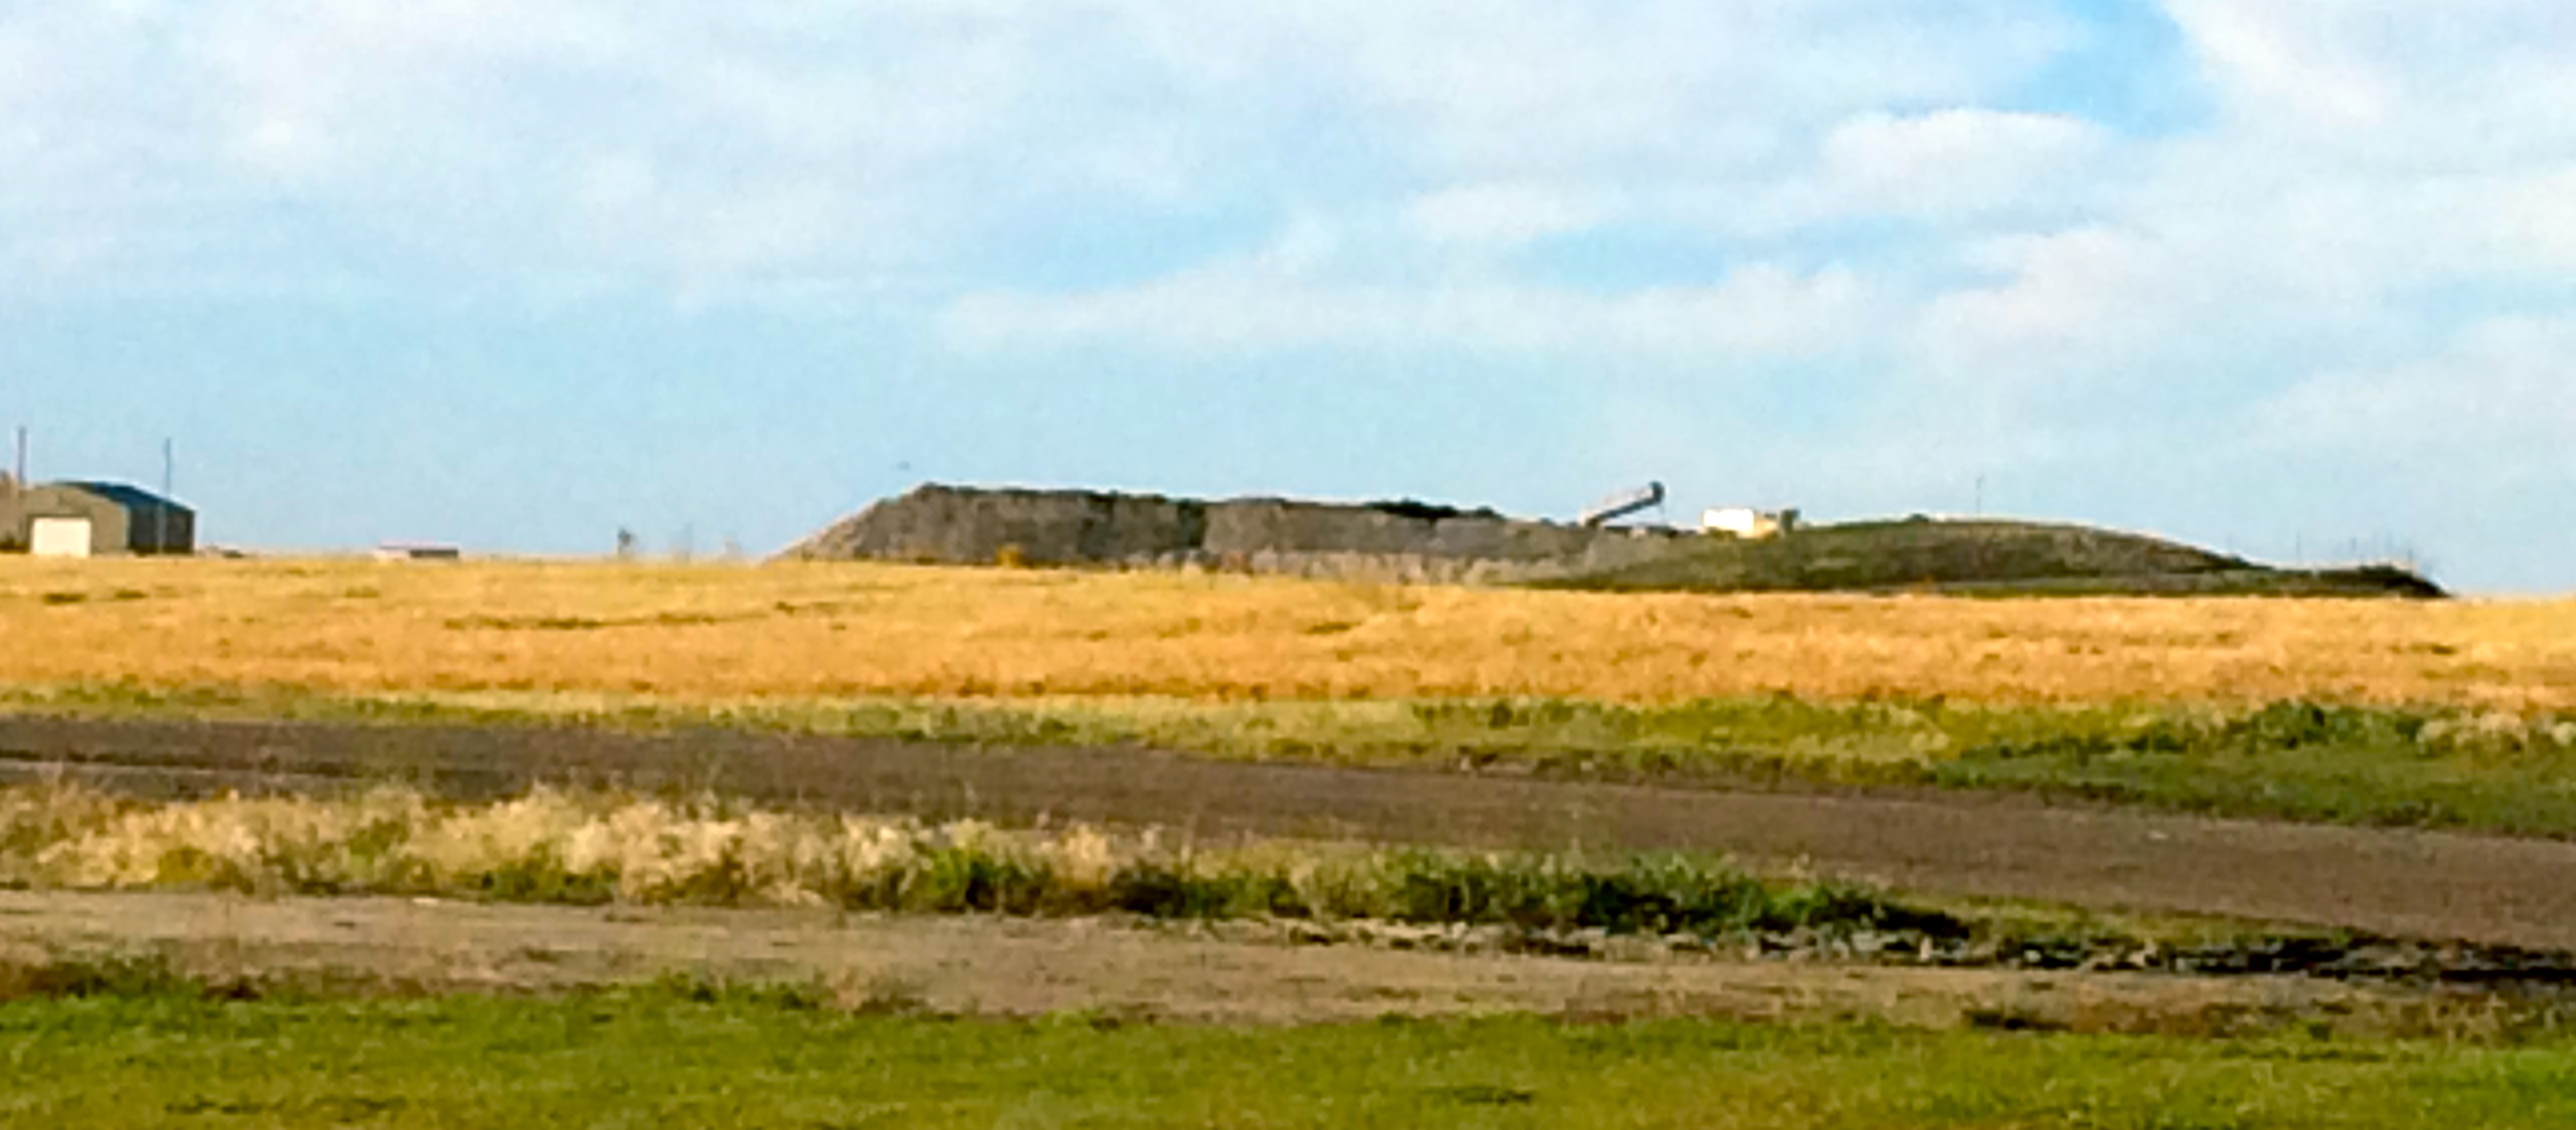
<box><xmin>0</xmin><ymin>986</ymin><xmax>2576</xmax><ymax>1130</ymax></box>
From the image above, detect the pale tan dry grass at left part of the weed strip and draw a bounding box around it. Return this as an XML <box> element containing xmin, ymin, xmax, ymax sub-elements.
<box><xmin>0</xmin><ymin>788</ymin><xmax>1076</xmax><ymax>911</ymax></box>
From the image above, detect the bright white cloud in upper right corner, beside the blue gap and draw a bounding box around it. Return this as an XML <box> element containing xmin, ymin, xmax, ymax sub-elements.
<box><xmin>1891</xmin><ymin>0</ymin><xmax>2576</xmax><ymax>401</ymax></box>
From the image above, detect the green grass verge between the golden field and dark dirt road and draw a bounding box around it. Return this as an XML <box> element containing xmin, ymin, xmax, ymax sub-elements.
<box><xmin>0</xmin><ymin>685</ymin><xmax>2576</xmax><ymax>836</ymax></box>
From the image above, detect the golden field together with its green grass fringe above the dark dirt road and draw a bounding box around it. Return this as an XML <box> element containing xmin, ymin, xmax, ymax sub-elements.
<box><xmin>0</xmin><ymin>561</ymin><xmax>2576</xmax><ymax>836</ymax></box>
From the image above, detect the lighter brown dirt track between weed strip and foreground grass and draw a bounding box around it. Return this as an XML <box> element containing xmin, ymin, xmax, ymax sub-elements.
<box><xmin>0</xmin><ymin>891</ymin><xmax>2475</xmax><ymax>1035</ymax></box>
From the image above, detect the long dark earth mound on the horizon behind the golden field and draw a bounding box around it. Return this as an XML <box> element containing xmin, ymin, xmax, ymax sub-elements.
<box><xmin>783</xmin><ymin>484</ymin><xmax>2442</xmax><ymax>597</ymax></box>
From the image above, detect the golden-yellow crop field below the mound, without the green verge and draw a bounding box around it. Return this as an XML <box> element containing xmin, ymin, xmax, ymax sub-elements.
<box><xmin>0</xmin><ymin>559</ymin><xmax>2576</xmax><ymax>710</ymax></box>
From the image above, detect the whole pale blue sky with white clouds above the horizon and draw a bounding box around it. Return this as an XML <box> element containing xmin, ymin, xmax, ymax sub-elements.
<box><xmin>0</xmin><ymin>0</ymin><xmax>2576</xmax><ymax>592</ymax></box>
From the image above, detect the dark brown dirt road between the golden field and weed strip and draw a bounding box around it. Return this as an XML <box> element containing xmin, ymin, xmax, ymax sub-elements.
<box><xmin>0</xmin><ymin>718</ymin><xmax>2576</xmax><ymax>950</ymax></box>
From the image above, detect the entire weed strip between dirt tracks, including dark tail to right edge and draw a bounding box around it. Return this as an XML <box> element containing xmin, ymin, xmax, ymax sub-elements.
<box><xmin>0</xmin><ymin>788</ymin><xmax>2576</xmax><ymax>989</ymax></box>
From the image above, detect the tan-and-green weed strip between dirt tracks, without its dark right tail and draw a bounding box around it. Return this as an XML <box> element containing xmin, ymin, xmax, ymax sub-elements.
<box><xmin>0</xmin><ymin>788</ymin><xmax>1916</xmax><ymax>937</ymax></box>
